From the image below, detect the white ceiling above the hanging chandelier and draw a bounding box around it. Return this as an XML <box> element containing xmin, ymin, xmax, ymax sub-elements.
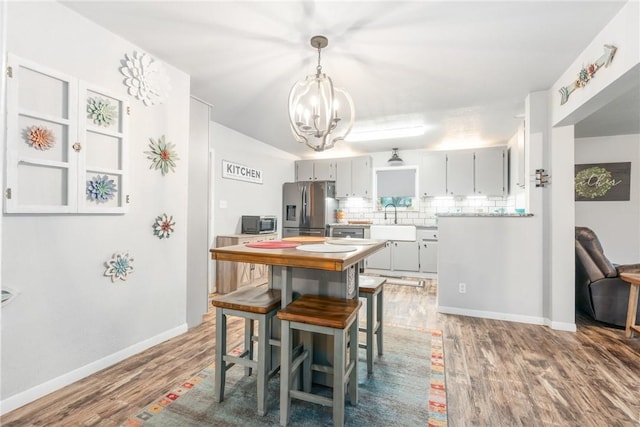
<box><xmin>63</xmin><ymin>0</ymin><xmax>640</xmax><ymax>157</ymax></box>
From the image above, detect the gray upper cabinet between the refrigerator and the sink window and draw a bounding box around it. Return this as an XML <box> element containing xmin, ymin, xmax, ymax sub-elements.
<box><xmin>336</xmin><ymin>156</ymin><xmax>373</xmax><ymax>199</ymax></box>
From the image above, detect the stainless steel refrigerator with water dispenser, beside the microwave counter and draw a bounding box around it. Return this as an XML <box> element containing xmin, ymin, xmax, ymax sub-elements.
<box><xmin>282</xmin><ymin>181</ymin><xmax>338</xmax><ymax>237</ymax></box>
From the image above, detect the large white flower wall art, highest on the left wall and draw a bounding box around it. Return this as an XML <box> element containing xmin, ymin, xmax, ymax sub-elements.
<box><xmin>120</xmin><ymin>51</ymin><xmax>169</xmax><ymax>106</ymax></box>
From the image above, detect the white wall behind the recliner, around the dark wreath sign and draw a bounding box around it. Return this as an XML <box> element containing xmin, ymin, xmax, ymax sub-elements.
<box><xmin>575</xmin><ymin>134</ymin><xmax>640</xmax><ymax>264</ymax></box>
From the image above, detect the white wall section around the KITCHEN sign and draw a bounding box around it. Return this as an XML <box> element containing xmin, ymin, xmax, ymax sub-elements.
<box><xmin>211</xmin><ymin>122</ymin><xmax>298</xmax><ymax>239</ymax></box>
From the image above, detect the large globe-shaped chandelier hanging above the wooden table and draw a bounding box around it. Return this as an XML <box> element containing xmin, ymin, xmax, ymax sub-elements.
<box><xmin>289</xmin><ymin>36</ymin><xmax>354</xmax><ymax>151</ymax></box>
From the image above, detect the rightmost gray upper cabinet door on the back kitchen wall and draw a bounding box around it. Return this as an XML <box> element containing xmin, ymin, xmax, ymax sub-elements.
<box><xmin>474</xmin><ymin>147</ymin><xmax>507</xmax><ymax>196</ymax></box>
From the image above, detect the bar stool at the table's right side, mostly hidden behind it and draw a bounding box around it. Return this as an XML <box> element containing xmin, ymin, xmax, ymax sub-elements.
<box><xmin>358</xmin><ymin>275</ymin><xmax>387</xmax><ymax>375</ymax></box>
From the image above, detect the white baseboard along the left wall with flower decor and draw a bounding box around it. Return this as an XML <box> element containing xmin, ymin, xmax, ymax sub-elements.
<box><xmin>0</xmin><ymin>323</ymin><xmax>188</xmax><ymax>415</ymax></box>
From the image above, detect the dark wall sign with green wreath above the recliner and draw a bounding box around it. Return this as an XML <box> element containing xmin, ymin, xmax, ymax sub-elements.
<box><xmin>574</xmin><ymin>162</ymin><xmax>631</xmax><ymax>202</ymax></box>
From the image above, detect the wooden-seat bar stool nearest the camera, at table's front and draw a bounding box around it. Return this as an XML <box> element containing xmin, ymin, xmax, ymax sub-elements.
<box><xmin>278</xmin><ymin>295</ymin><xmax>362</xmax><ymax>426</ymax></box>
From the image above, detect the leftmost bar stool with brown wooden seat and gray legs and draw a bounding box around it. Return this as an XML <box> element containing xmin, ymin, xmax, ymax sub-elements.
<box><xmin>211</xmin><ymin>287</ymin><xmax>280</xmax><ymax>415</ymax></box>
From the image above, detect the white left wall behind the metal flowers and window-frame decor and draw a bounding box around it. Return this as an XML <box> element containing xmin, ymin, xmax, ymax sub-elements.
<box><xmin>1</xmin><ymin>2</ymin><xmax>190</xmax><ymax>412</ymax></box>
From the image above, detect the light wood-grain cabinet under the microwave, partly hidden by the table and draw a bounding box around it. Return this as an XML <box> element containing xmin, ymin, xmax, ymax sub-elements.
<box><xmin>216</xmin><ymin>233</ymin><xmax>278</xmax><ymax>294</ymax></box>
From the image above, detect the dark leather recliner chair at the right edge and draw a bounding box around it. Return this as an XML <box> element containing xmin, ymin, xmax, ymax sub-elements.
<box><xmin>576</xmin><ymin>227</ymin><xmax>640</xmax><ymax>327</ymax></box>
